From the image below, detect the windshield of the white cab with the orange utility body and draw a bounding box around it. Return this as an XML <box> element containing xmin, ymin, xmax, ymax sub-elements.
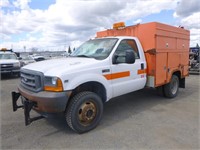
<box><xmin>70</xmin><ymin>38</ymin><xmax>118</xmax><ymax>60</ymax></box>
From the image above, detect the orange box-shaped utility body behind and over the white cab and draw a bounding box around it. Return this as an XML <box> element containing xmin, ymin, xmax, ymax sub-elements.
<box><xmin>97</xmin><ymin>22</ymin><xmax>190</xmax><ymax>87</ymax></box>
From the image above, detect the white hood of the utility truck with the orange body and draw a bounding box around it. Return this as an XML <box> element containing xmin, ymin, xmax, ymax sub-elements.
<box><xmin>23</xmin><ymin>57</ymin><xmax>99</xmax><ymax>76</ymax></box>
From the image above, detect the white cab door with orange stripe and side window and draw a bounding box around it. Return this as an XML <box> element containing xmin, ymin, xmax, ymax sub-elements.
<box><xmin>111</xmin><ymin>39</ymin><xmax>146</xmax><ymax>97</ymax></box>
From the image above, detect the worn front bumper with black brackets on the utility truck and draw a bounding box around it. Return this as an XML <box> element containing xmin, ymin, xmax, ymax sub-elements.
<box><xmin>12</xmin><ymin>86</ymin><xmax>71</xmax><ymax>125</ymax></box>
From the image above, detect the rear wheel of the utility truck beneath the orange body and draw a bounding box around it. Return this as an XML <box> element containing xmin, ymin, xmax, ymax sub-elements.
<box><xmin>164</xmin><ymin>75</ymin><xmax>179</xmax><ymax>98</ymax></box>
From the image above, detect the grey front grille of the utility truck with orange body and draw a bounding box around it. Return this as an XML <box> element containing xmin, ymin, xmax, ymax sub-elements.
<box><xmin>20</xmin><ymin>69</ymin><xmax>43</xmax><ymax>92</ymax></box>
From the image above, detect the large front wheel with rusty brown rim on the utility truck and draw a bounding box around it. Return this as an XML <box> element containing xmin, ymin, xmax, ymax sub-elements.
<box><xmin>65</xmin><ymin>92</ymin><xmax>103</xmax><ymax>133</ymax></box>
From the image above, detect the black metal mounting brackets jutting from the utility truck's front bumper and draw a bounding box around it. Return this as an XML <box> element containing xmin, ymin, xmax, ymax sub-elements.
<box><xmin>12</xmin><ymin>92</ymin><xmax>44</xmax><ymax>126</ymax></box>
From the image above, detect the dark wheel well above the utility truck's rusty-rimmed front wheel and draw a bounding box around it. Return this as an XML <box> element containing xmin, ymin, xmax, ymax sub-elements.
<box><xmin>70</xmin><ymin>81</ymin><xmax>106</xmax><ymax>102</ymax></box>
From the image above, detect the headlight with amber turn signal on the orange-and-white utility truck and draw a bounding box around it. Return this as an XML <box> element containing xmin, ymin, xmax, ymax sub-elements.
<box><xmin>44</xmin><ymin>77</ymin><xmax>63</xmax><ymax>92</ymax></box>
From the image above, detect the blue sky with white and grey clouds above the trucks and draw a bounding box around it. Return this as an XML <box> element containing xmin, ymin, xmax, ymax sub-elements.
<box><xmin>0</xmin><ymin>0</ymin><xmax>200</xmax><ymax>51</ymax></box>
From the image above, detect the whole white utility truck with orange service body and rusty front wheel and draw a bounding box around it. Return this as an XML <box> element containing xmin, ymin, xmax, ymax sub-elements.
<box><xmin>12</xmin><ymin>22</ymin><xmax>190</xmax><ymax>133</ymax></box>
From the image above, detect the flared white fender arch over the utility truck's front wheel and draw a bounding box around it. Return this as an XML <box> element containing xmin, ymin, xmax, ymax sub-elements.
<box><xmin>63</xmin><ymin>73</ymin><xmax>112</xmax><ymax>101</ymax></box>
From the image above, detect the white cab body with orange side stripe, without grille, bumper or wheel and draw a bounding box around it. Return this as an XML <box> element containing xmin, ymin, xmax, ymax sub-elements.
<box><xmin>21</xmin><ymin>37</ymin><xmax>146</xmax><ymax>98</ymax></box>
